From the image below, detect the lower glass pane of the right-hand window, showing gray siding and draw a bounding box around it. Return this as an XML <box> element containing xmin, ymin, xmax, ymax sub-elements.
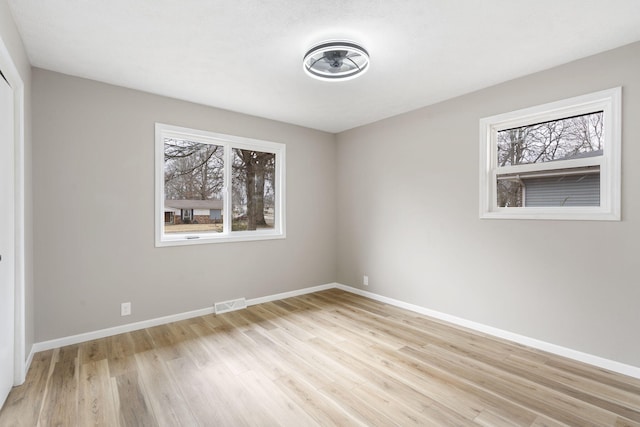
<box><xmin>496</xmin><ymin>166</ymin><xmax>600</xmax><ymax>207</ymax></box>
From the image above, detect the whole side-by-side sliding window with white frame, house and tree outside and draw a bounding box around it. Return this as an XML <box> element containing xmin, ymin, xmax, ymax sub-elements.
<box><xmin>156</xmin><ymin>123</ymin><xmax>285</xmax><ymax>246</ymax></box>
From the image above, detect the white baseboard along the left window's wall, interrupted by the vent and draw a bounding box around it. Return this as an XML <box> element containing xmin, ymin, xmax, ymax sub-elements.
<box><xmin>31</xmin><ymin>283</ymin><xmax>337</xmax><ymax>354</ymax></box>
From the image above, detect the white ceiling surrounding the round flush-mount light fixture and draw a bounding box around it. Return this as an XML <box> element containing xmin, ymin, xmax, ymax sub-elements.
<box><xmin>8</xmin><ymin>0</ymin><xmax>640</xmax><ymax>132</ymax></box>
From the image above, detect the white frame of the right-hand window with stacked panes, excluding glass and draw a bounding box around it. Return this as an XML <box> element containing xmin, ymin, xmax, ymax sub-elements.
<box><xmin>480</xmin><ymin>87</ymin><xmax>622</xmax><ymax>221</ymax></box>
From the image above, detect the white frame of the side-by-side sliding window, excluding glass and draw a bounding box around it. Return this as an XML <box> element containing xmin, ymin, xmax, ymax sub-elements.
<box><xmin>155</xmin><ymin>123</ymin><xmax>286</xmax><ymax>247</ymax></box>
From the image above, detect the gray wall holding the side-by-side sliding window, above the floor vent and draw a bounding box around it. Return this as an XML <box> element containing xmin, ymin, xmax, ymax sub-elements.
<box><xmin>33</xmin><ymin>69</ymin><xmax>337</xmax><ymax>341</ymax></box>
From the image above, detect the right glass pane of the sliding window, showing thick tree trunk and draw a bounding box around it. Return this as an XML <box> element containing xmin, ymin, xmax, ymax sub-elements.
<box><xmin>231</xmin><ymin>148</ymin><xmax>276</xmax><ymax>231</ymax></box>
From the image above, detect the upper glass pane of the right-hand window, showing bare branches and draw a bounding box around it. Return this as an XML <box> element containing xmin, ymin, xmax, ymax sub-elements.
<box><xmin>497</xmin><ymin>111</ymin><xmax>604</xmax><ymax>167</ymax></box>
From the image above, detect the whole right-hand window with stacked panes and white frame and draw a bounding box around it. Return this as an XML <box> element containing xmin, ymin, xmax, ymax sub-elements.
<box><xmin>480</xmin><ymin>88</ymin><xmax>622</xmax><ymax>220</ymax></box>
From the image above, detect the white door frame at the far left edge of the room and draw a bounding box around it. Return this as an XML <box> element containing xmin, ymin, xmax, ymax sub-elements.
<box><xmin>0</xmin><ymin>31</ymin><xmax>26</xmax><ymax>385</ymax></box>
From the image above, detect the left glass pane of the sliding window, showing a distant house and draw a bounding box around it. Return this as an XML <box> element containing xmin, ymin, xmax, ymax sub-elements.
<box><xmin>164</xmin><ymin>138</ymin><xmax>224</xmax><ymax>234</ymax></box>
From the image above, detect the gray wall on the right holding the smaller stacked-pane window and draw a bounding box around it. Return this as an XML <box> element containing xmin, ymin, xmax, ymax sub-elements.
<box><xmin>338</xmin><ymin>43</ymin><xmax>640</xmax><ymax>366</ymax></box>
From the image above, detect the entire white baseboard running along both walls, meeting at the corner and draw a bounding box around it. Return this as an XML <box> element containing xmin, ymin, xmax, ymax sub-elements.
<box><xmin>25</xmin><ymin>283</ymin><xmax>640</xmax><ymax>379</ymax></box>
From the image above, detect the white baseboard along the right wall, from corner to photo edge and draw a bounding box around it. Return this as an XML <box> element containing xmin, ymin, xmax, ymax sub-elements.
<box><xmin>336</xmin><ymin>283</ymin><xmax>640</xmax><ymax>379</ymax></box>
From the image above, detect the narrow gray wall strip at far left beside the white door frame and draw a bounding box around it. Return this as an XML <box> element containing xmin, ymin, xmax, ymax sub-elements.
<box><xmin>0</xmin><ymin>0</ymin><xmax>35</xmax><ymax>372</ymax></box>
